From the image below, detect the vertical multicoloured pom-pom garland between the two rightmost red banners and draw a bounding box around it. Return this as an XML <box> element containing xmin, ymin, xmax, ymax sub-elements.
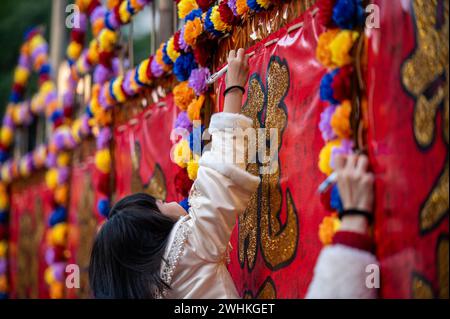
<box><xmin>316</xmin><ymin>0</ymin><xmax>364</xmax><ymax>245</ymax></box>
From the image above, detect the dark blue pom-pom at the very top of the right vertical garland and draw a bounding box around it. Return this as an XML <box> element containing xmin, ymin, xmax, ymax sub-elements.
<box><xmin>333</xmin><ymin>0</ymin><xmax>364</xmax><ymax>29</ymax></box>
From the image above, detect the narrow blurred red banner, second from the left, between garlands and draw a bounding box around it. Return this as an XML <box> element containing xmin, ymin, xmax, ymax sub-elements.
<box><xmin>66</xmin><ymin>157</ymin><xmax>98</xmax><ymax>298</ymax></box>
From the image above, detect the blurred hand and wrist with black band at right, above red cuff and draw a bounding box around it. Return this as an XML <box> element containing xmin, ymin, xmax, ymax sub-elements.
<box><xmin>335</xmin><ymin>155</ymin><xmax>374</xmax><ymax>233</ymax></box>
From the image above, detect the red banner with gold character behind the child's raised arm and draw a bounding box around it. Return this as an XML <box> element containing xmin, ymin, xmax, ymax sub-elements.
<box><xmin>217</xmin><ymin>11</ymin><xmax>327</xmax><ymax>298</ymax></box>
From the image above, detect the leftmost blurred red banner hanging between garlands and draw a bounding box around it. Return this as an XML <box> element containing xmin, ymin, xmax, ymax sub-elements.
<box><xmin>9</xmin><ymin>179</ymin><xmax>53</xmax><ymax>299</ymax></box>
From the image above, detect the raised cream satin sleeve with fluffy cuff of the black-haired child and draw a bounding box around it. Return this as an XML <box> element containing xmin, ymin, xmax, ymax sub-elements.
<box><xmin>189</xmin><ymin>113</ymin><xmax>260</xmax><ymax>262</ymax></box>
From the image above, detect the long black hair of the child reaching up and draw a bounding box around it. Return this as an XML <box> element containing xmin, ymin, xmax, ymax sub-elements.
<box><xmin>89</xmin><ymin>194</ymin><xmax>174</xmax><ymax>299</ymax></box>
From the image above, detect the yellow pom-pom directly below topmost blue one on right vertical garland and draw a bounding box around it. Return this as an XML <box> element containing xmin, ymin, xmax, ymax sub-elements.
<box><xmin>330</xmin><ymin>30</ymin><xmax>359</xmax><ymax>67</ymax></box>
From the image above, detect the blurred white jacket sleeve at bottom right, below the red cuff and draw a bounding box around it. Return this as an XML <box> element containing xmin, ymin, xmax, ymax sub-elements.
<box><xmin>306</xmin><ymin>244</ymin><xmax>380</xmax><ymax>299</ymax></box>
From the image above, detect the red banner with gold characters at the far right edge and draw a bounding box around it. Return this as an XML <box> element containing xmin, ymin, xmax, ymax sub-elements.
<box><xmin>367</xmin><ymin>0</ymin><xmax>449</xmax><ymax>298</ymax></box>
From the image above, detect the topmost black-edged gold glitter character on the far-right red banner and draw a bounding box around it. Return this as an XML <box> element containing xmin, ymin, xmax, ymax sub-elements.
<box><xmin>402</xmin><ymin>0</ymin><xmax>449</xmax><ymax>232</ymax></box>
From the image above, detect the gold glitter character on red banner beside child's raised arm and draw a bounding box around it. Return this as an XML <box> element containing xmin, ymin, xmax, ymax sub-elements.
<box><xmin>239</xmin><ymin>57</ymin><xmax>298</xmax><ymax>270</ymax></box>
